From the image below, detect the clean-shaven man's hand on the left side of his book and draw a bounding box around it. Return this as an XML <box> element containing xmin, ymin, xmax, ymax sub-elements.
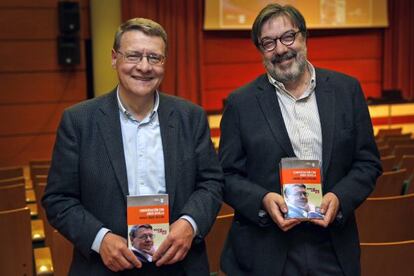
<box><xmin>99</xmin><ymin>232</ymin><xmax>142</xmax><ymax>272</ymax></box>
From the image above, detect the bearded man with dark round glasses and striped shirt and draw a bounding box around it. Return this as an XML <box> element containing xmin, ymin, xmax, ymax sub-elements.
<box><xmin>219</xmin><ymin>4</ymin><xmax>381</xmax><ymax>276</ymax></box>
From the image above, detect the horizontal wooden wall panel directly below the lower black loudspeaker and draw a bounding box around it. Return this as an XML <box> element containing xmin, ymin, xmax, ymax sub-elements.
<box><xmin>0</xmin><ymin>71</ymin><xmax>86</xmax><ymax>105</ymax></box>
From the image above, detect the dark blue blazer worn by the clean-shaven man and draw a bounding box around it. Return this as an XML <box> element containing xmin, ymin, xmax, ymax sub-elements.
<box><xmin>43</xmin><ymin>91</ymin><xmax>223</xmax><ymax>276</ymax></box>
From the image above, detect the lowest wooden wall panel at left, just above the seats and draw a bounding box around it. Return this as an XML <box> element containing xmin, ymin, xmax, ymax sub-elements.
<box><xmin>0</xmin><ymin>132</ymin><xmax>56</xmax><ymax>167</ymax></box>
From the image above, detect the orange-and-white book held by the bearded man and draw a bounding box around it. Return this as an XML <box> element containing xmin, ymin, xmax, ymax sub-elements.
<box><xmin>280</xmin><ymin>158</ymin><xmax>323</xmax><ymax>220</ymax></box>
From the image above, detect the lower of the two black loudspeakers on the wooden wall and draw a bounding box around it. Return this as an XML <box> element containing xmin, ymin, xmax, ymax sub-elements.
<box><xmin>58</xmin><ymin>35</ymin><xmax>80</xmax><ymax>65</ymax></box>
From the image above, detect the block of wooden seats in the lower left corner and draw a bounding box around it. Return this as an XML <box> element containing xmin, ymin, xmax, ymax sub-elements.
<box><xmin>0</xmin><ymin>160</ymin><xmax>72</xmax><ymax>276</ymax></box>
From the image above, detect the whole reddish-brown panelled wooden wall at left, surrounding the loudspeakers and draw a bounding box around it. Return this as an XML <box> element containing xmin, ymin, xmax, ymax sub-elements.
<box><xmin>0</xmin><ymin>0</ymin><xmax>90</xmax><ymax>166</ymax></box>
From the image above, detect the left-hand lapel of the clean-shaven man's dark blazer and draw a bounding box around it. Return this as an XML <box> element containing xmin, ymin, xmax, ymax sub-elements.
<box><xmin>97</xmin><ymin>90</ymin><xmax>129</xmax><ymax>201</ymax></box>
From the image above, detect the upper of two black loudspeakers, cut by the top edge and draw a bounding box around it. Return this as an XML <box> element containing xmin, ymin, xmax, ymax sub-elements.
<box><xmin>58</xmin><ymin>1</ymin><xmax>80</xmax><ymax>34</ymax></box>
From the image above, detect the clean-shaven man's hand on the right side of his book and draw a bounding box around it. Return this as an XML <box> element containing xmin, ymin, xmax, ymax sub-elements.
<box><xmin>152</xmin><ymin>219</ymin><xmax>194</xmax><ymax>266</ymax></box>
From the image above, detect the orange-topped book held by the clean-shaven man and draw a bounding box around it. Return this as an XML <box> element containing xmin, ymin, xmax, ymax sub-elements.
<box><xmin>127</xmin><ymin>194</ymin><xmax>170</xmax><ymax>263</ymax></box>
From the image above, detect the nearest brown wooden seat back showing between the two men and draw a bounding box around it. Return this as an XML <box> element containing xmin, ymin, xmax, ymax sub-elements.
<box><xmin>206</xmin><ymin>214</ymin><xmax>234</xmax><ymax>273</ymax></box>
